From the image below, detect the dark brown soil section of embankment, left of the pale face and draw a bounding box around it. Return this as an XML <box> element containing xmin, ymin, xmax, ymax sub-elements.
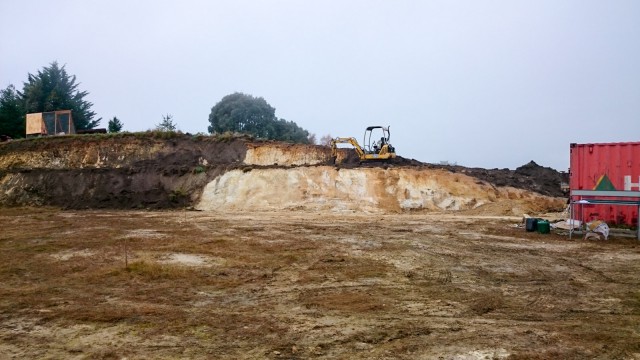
<box><xmin>0</xmin><ymin>133</ymin><xmax>247</xmax><ymax>209</ymax></box>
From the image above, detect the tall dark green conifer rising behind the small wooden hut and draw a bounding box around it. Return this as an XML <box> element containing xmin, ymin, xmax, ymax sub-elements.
<box><xmin>19</xmin><ymin>61</ymin><xmax>101</xmax><ymax>130</ymax></box>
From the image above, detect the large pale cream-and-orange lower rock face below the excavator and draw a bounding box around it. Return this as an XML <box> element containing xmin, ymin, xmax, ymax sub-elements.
<box><xmin>196</xmin><ymin>166</ymin><xmax>562</xmax><ymax>215</ymax></box>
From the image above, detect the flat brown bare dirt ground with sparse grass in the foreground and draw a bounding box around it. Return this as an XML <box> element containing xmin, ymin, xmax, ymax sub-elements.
<box><xmin>0</xmin><ymin>208</ymin><xmax>640</xmax><ymax>359</ymax></box>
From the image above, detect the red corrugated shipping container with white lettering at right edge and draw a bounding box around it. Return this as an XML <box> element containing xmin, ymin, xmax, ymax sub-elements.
<box><xmin>569</xmin><ymin>142</ymin><xmax>640</xmax><ymax>226</ymax></box>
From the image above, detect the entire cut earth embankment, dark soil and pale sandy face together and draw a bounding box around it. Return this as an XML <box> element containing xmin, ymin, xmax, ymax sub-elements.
<box><xmin>0</xmin><ymin>133</ymin><xmax>564</xmax><ymax>215</ymax></box>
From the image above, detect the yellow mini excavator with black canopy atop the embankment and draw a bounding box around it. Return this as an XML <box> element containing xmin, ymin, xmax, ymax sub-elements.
<box><xmin>331</xmin><ymin>126</ymin><xmax>396</xmax><ymax>162</ymax></box>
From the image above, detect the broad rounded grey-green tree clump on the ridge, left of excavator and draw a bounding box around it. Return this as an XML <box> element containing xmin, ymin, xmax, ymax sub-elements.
<box><xmin>209</xmin><ymin>92</ymin><xmax>309</xmax><ymax>144</ymax></box>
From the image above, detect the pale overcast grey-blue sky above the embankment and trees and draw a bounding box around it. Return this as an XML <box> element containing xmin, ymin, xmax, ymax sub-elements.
<box><xmin>0</xmin><ymin>0</ymin><xmax>640</xmax><ymax>170</ymax></box>
